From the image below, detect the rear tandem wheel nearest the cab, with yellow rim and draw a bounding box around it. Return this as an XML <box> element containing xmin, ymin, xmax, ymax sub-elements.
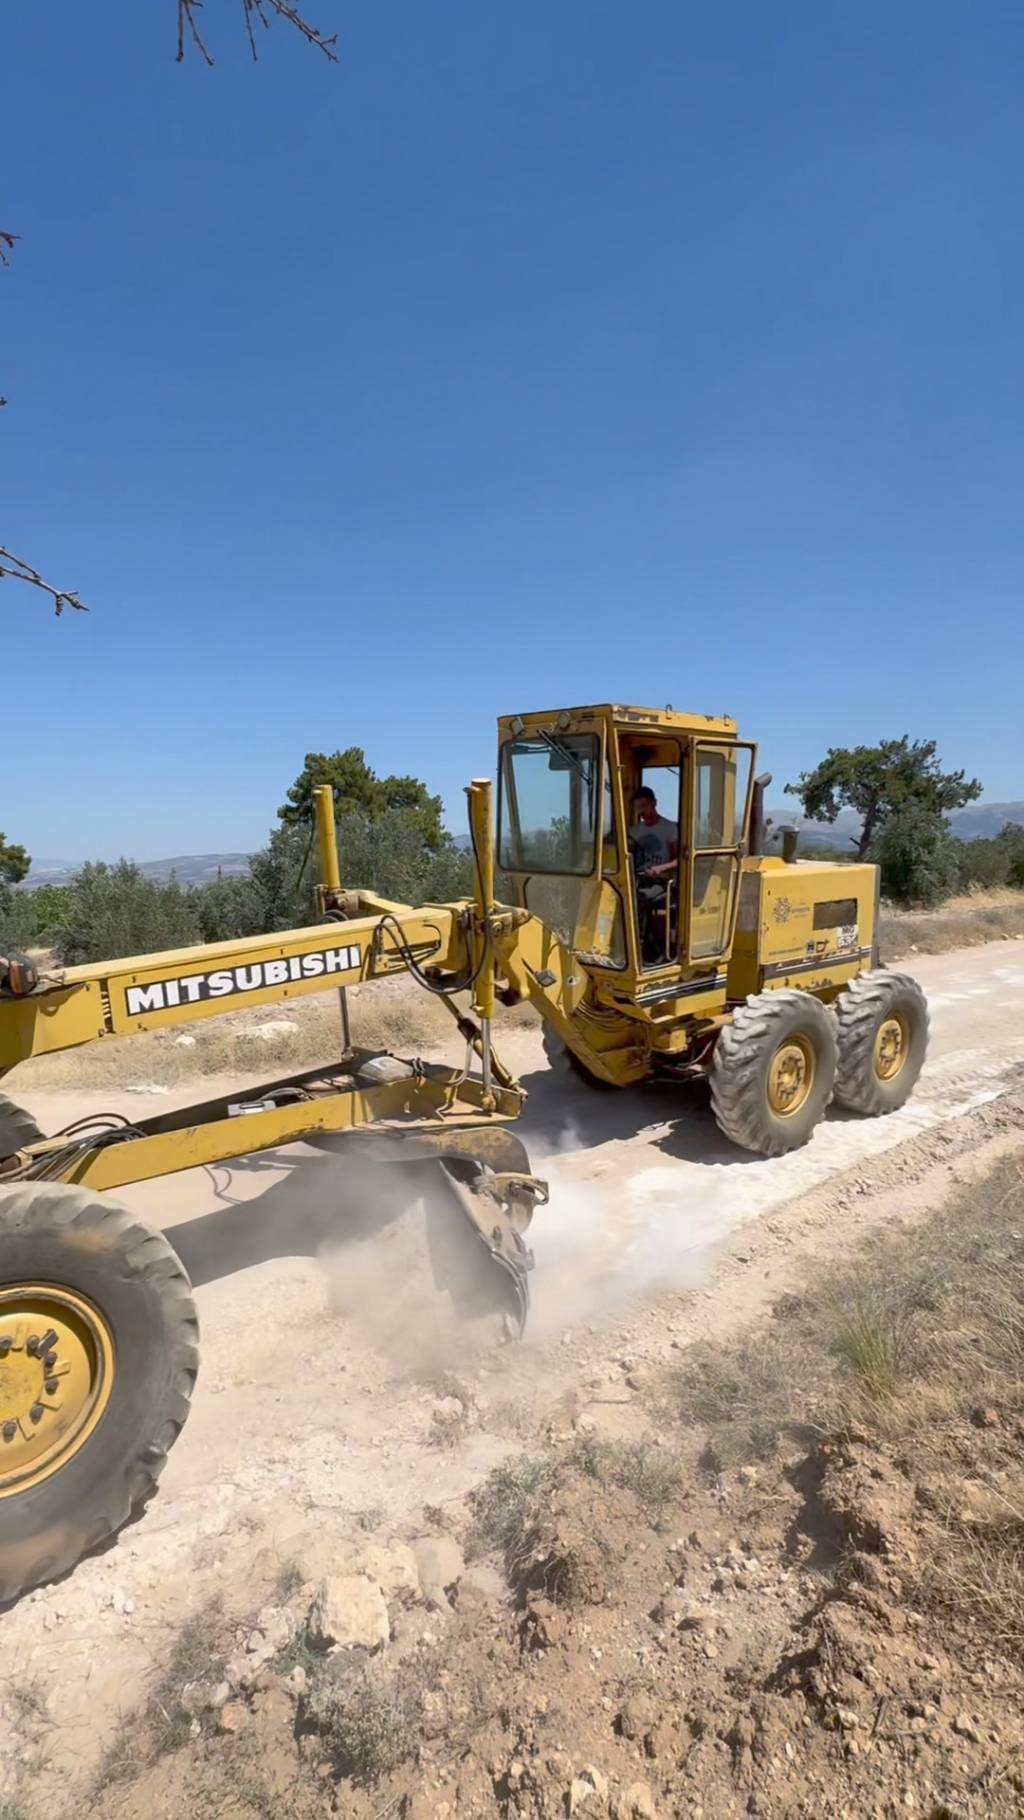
<box><xmin>711</xmin><ymin>988</ymin><xmax>837</xmax><ymax>1156</ymax></box>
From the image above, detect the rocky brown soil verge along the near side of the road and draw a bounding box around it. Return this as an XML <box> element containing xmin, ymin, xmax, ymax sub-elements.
<box><xmin>2</xmin><ymin>1092</ymin><xmax>1024</xmax><ymax>1820</ymax></box>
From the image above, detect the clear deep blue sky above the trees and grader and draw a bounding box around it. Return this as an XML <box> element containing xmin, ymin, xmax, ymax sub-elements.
<box><xmin>0</xmin><ymin>0</ymin><xmax>1024</xmax><ymax>859</ymax></box>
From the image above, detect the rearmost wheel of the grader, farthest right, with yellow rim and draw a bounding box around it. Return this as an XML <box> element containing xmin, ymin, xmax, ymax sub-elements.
<box><xmin>835</xmin><ymin>972</ymin><xmax>928</xmax><ymax>1117</ymax></box>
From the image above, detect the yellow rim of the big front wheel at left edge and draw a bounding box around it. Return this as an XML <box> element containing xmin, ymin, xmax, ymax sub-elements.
<box><xmin>0</xmin><ymin>1283</ymin><xmax>115</xmax><ymax>1498</ymax></box>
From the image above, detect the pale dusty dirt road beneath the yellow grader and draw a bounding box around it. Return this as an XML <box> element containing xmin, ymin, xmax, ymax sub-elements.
<box><xmin>0</xmin><ymin>943</ymin><xmax>1024</xmax><ymax>1793</ymax></box>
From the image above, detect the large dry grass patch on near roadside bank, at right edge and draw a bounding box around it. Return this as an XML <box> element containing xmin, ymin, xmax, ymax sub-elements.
<box><xmin>669</xmin><ymin>1161</ymin><xmax>1024</xmax><ymax>1469</ymax></box>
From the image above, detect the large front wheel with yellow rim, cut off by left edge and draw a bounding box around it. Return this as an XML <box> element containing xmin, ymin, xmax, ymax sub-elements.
<box><xmin>0</xmin><ymin>1183</ymin><xmax>198</xmax><ymax>1602</ymax></box>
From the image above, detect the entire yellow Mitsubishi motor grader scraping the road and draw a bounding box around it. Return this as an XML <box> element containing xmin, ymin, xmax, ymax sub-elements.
<box><xmin>0</xmin><ymin>706</ymin><xmax>928</xmax><ymax>1600</ymax></box>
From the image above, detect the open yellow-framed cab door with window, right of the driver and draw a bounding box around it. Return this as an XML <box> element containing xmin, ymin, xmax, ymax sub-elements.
<box><xmin>680</xmin><ymin>739</ymin><xmax>755</xmax><ymax>966</ymax></box>
